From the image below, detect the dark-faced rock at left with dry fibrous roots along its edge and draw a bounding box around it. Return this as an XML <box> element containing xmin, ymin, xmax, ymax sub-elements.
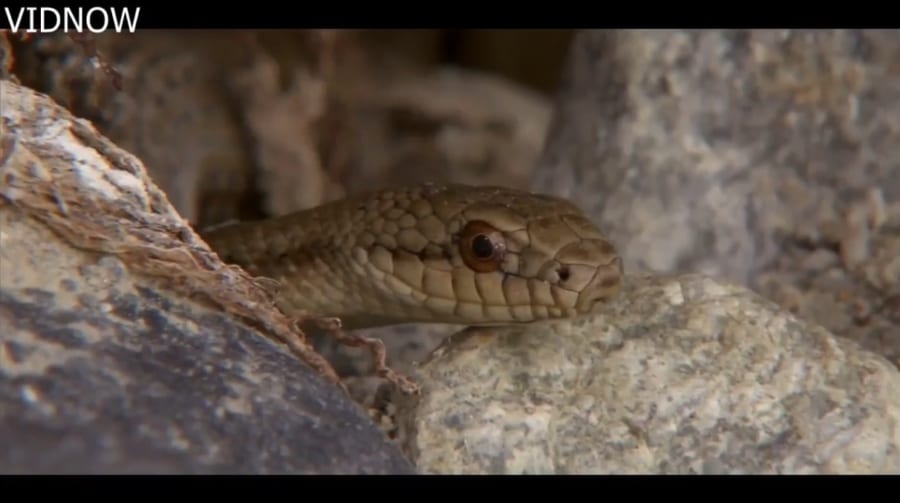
<box><xmin>0</xmin><ymin>81</ymin><xmax>411</xmax><ymax>473</ymax></box>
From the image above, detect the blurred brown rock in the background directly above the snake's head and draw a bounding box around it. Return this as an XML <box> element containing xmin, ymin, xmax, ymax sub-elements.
<box><xmin>341</xmin><ymin>68</ymin><xmax>552</xmax><ymax>193</ymax></box>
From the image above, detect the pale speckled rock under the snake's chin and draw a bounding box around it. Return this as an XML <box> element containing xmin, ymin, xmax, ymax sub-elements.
<box><xmin>397</xmin><ymin>275</ymin><xmax>900</xmax><ymax>474</ymax></box>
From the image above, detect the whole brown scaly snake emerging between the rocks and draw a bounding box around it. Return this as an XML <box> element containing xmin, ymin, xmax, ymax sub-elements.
<box><xmin>201</xmin><ymin>183</ymin><xmax>623</xmax><ymax>329</ymax></box>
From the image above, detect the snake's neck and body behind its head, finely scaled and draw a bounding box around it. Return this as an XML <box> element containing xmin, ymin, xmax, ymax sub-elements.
<box><xmin>202</xmin><ymin>205</ymin><xmax>433</xmax><ymax>329</ymax></box>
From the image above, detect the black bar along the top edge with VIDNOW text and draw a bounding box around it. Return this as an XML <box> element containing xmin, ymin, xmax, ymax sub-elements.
<box><xmin>0</xmin><ymin>0</ymin><xmax>889</xmax><ymax>33</ymax></box>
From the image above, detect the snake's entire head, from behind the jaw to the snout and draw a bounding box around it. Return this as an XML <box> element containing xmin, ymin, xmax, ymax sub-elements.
<box><xmin>361</xmin><ymin>185</ymin><xmax>623</xmax><ymax>325</ymax></box>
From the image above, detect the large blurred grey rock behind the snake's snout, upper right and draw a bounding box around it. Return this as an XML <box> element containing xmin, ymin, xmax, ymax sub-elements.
<box><xmin>533</xmin><ymin>30</ymin><xmax>900</xmax><ymax>365</ymax></box>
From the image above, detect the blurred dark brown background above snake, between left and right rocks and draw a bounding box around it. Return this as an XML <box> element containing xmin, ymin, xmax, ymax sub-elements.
<box><xmin>8</xmin><ymin>30</ymin><xmax>572</xmax><ymax>227</ymax></box>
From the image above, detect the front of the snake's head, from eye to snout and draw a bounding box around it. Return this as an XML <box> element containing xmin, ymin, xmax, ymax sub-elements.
<box><xmin>442</xmin><ymin>189</ymin><xmax>623</xmax><ymax>323</ymax></box>
